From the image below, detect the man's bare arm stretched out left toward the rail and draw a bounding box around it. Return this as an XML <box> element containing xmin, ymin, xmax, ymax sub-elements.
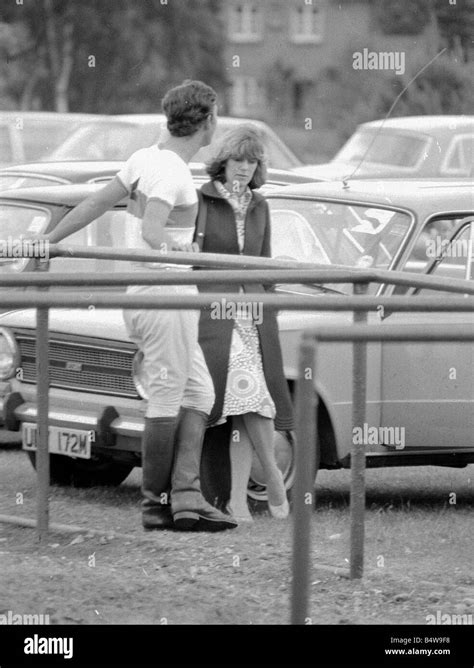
<box><xmin>48</xmin><ymin>178</ymin><xmax>127</xmax><ymax>244</ymax></box>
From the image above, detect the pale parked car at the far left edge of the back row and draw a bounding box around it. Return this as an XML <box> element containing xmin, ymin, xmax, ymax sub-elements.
<box><xmin>0</xmin><ymin>111</ymin><xmax>99</xmax><ymax>166</ymax></box>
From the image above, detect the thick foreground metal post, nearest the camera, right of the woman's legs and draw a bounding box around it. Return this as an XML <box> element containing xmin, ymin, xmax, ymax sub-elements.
<box><xmin>291</xmin><ymin>337</ymin><xmax>317</xmax><ymax>624</ymax></box>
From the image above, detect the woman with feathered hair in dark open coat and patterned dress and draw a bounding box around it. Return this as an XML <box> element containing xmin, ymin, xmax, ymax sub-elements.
<box><xmin>195</xmin><ymin>124</ymin><xmax>294</xmax><ymax>521</ymax></box>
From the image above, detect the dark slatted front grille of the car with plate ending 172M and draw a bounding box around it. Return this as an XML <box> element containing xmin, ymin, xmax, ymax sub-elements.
<box><xmin>15</xmin><ymin>334</ymin><xmax>139</xmax><ymax>399</ymax></box>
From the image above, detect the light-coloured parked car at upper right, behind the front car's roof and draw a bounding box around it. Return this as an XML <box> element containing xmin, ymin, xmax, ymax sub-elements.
<box><xmin>295</xmin><ymin>116</ymin><xmax>474</xmax><ymax>179</ymax></box>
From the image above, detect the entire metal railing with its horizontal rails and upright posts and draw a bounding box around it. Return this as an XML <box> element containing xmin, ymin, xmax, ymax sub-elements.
<box><xmin>0</xmin><ymin>244</ymin><xmax>474</xmax><ymax>624</ymax></box>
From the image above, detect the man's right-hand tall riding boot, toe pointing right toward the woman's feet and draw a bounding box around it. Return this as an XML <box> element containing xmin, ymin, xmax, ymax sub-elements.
<box><xmin>171</xmin><ymin>408</ymin><xmax>237</xmax><ymax>531</ymax></box>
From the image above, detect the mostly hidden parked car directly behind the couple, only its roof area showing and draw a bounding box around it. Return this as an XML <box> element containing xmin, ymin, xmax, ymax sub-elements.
<box><xmin>0</xmin><ymin>160</ymin><xmax>316</xmax><ymax>191</ymax></box>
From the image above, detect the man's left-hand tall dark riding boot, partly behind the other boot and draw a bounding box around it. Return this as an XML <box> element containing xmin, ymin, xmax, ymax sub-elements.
<box><xmin>142</xmin><ymin>417</ymin><xmax>177</xmax><ymax>529</ymax></box>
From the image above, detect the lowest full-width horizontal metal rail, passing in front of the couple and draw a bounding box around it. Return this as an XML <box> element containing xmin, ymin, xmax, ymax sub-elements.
<box><xmin>0</xmin><ymin>292</ymin><xmax>474</xmax><ymax>312</ymax></box>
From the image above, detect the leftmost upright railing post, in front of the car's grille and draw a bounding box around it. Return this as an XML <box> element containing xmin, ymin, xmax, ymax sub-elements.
<box><xmin>36</xmin><ymin>261</ymin><xmax>49</xmax><ymax>543</ymax></box>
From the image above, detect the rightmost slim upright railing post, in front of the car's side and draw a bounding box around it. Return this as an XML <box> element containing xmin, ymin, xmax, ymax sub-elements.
<box><xmin>350</xmin><ymin>283</ymin><xmax>369</xmax><ymax>579</ymax></box>
